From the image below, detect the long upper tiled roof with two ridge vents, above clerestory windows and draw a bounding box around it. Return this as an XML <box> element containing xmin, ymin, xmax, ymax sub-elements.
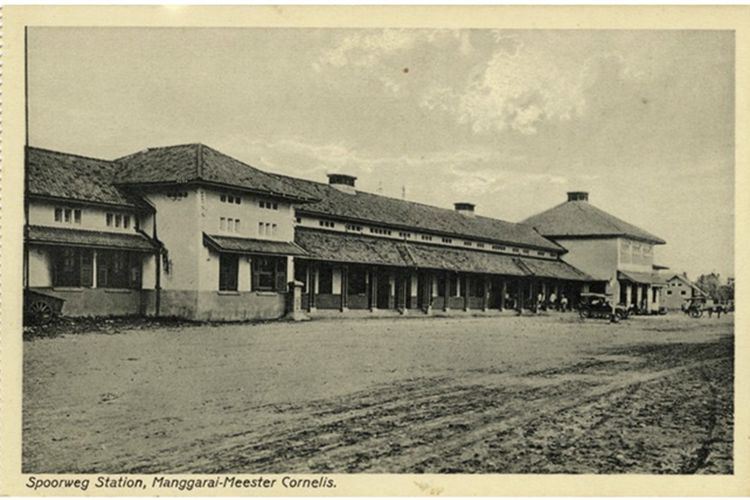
<box><xmin>278</xmin><ymin>176</ymin><xmax>563</xmax><ymax>252</ymax></box>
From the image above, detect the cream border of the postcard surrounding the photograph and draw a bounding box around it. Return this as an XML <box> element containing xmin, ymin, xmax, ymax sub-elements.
<box><xmin>0</xmin><ymin>6</ymin><xmax>750</xmax><ymax>496</ymax></box>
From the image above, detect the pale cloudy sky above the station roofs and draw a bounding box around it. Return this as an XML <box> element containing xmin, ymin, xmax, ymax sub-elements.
<box><xmin>28</xmin><ymin>28</ymin><xmax>734</xmax><ymax>278</ymax></box>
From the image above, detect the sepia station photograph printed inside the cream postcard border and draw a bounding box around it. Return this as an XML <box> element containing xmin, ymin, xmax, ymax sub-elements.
<box><xmin>2</xmin><ymin>7</ymin><xmax>748</xmax><ymax>493</ymax></box>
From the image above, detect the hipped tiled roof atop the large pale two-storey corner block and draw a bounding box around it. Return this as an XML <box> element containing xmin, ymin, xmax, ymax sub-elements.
<box><xmin>116</xmin><ymin>144</ymin><xmax>318</xmax><ymax>201</ymax></box>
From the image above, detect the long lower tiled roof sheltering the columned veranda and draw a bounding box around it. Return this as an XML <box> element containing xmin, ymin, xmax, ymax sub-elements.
<box><xmin>294</xmin><ymin>227</ymin><xmax>590</xmax><ymax>281</ymax></box>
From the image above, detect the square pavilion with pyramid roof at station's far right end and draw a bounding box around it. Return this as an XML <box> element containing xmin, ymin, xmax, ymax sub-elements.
<box><xmin>523</xmin><ymin>191</ymin><xmax>665</xmax><ymax>311</ymax></box>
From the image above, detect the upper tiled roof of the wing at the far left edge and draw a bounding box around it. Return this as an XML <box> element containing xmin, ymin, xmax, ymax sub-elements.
<box><xmin>27</xmin><ymin>147</ymin><xmax>141</xmax><ymax>207</ymax></box>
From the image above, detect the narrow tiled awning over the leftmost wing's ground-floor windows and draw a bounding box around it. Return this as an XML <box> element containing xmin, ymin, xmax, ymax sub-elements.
<box><xmin>27</xmin><ymin>226</ymin><xmax>158</xmax><ymax>252</ymax></box>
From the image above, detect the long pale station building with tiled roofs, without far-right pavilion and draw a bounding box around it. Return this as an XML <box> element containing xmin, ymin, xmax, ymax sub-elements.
<box><xmin>24</xmin><ymin>144</ymin><xmax>593</xmax><ymax>320</ymax></box>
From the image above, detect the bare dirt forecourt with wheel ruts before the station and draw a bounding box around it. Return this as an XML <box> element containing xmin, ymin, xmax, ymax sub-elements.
<box><xmin>23</xmin><ymin>314</ymin><xmax>734</xmax><ymax>474</ymax></box>
